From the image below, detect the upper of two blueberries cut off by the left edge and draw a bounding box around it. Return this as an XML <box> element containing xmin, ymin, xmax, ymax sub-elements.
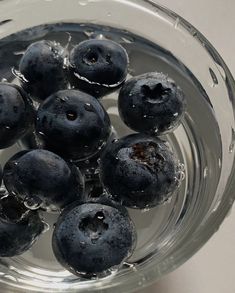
<box><xmin>0</xmin><ymin>82</ymin><xmax>35</xmax><ymax>149</ymax></box>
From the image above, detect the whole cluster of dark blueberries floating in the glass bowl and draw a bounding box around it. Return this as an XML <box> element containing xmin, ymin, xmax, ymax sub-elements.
<box><xmin>0</xmin><ymin>39</ymin><xmax>185</xmax><ymax>277</ymax></box>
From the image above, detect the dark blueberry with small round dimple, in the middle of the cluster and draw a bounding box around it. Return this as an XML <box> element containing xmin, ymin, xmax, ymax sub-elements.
<box><xmin>36</xmin><ymin>90</ymin><xmax>111</xmax><ymax>161</ymax></box>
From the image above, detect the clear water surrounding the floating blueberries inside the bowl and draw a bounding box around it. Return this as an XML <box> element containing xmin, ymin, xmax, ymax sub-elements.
<box><xmin>0</xmin><ymin>23</ymin><xmax>222</xmax><ymax>288</ymax></box>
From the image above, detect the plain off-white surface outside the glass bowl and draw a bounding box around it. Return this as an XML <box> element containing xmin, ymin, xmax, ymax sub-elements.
<box><xmin>139</xmin><ymin>0</ymin><xmax>235</xmax><ymax>293</ymax></box>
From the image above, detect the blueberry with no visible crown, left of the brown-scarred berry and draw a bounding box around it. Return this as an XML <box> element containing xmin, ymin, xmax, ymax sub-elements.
<box><xmin>3</xmin><ymin>149</ymin><xmax>83</xmax><ymax>209</ymax></box>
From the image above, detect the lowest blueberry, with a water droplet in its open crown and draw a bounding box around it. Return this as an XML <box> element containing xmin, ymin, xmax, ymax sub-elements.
<box><xmin>52</xmin><ymin>203</ymin><xmax>136</xmax><ymax>277</ymax></box>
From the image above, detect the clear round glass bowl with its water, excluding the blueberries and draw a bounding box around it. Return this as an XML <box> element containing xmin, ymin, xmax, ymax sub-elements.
<box><xmin>0</xmin><ymin>0</ymin><xmax>235</xmax><ymax>293</ymax></box>
